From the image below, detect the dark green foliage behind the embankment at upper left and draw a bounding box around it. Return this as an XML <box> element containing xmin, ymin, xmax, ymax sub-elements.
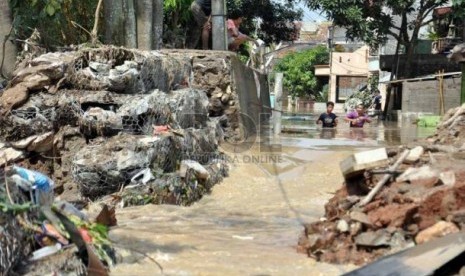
<box><xmin>9</xmin><ymin>0</ymin><xmax>98</xmax><ymax>50</ymax></box>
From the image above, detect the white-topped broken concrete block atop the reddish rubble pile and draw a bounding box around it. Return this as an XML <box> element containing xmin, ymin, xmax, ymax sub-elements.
<box><xmin>340</xmin><ymin>148</ymin><xmax>389</xmax><ymax>178</ymax></box>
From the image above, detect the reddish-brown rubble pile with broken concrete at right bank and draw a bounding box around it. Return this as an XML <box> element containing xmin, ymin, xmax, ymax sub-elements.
<box><xmin>298</xmin><ymin>105</ymin><xmax>465</xmax><ymax>265</ymax></box>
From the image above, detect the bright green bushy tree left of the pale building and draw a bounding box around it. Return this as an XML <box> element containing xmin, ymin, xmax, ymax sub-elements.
<box><xmin>274</xmin><ymin>46</ymin><xmax>329</xmax><ymax>98</ymax></box>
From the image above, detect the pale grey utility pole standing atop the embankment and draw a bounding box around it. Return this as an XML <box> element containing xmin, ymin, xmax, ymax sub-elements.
<box><xmin>211</xmin><ymin>0</ymin><xmax>228</xmax><ymax>51</ymax></box>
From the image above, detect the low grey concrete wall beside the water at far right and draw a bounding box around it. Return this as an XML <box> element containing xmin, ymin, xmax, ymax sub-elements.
<box><xmin>402</xmin><ymin>78</ymin><xmax>460</xmax><ymax>115</ymax></box>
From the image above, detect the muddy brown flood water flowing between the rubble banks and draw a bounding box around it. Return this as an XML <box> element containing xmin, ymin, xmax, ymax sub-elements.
<box><xmin>111</xmin><ymin>116</ymin><xmax>434</xmax><ymax>276</ymax></box>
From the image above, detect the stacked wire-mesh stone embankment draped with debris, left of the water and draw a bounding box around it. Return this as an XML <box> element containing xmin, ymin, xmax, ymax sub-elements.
<box><xmin>0</xmin><ymin>47</ymin><xmax>241</xmax><ymax>204</ymax></box>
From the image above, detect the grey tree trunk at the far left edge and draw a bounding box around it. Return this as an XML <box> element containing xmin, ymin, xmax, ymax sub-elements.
<box><xmin>0</xmin><ymin>0</ymin><xmax>16</xmax><ymax>78</ymax></box>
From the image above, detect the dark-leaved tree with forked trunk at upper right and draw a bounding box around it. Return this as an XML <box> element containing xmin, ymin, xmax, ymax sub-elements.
<box><xmin>306</xmin><ymin>0</ymin><xmax>448</xmax><ymax>76</ymax></box>
